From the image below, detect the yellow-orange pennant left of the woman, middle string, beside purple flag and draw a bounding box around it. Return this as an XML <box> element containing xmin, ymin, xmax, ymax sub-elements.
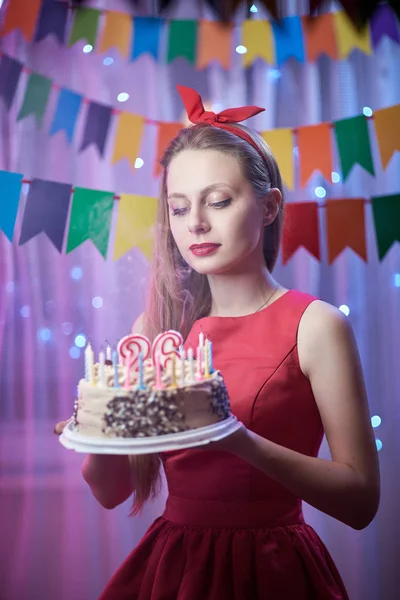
<box><xmin>112</xmin><ymin>112</ymin><xmax>144</xmax><ymax>167</ymax></box>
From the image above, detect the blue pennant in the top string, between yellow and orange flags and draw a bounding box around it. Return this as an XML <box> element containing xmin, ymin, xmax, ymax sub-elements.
<box><xmin>272</xmin><ymin>17</ymin><xmax>305</xmax><ymax>65</ymax></box>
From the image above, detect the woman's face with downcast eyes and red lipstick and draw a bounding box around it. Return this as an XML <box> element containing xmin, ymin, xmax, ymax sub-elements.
<box><xmin>167</xmin><ymin>150</ymin><xmax>265</xmax><ymax>275</ymax></box>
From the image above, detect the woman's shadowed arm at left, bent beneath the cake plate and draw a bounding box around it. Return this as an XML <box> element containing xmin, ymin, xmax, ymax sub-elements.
<box><xmin>82</xmin><ymin>315</ymin><xmax>143</xmax><ymax>508</ymax></box>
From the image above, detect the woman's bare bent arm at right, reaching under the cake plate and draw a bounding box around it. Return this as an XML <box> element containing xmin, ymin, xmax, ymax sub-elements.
<box><xmin>217</xmin><ymin>301</ymin><xmax>380</xmax><ymax>529</ymax></box>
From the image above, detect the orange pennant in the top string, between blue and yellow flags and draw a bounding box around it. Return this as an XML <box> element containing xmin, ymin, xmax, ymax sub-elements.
<box><xmin>302</xmin><ymin>13</ymin><xmax>338</xmax><ymax>62</ymax></box>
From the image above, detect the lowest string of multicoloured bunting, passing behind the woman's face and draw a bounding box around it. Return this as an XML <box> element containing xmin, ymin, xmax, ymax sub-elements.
<box><xmin>0</xmin><ymin>171</ymin><xmax>400</xmax><ymax>264</ymax></box>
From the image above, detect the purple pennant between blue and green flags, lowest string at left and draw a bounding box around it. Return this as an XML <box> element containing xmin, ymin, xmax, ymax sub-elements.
<box><xmin>19</xmin><ymin>179</ymin><xmax>71</xmax><ymax>252</ymax></box>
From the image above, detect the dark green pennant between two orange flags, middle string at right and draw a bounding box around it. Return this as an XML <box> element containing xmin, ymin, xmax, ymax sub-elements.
<box><xmin>334</xmin><ymin>115</ymin><xmax>374</xmax><ymax>179</ymax></box>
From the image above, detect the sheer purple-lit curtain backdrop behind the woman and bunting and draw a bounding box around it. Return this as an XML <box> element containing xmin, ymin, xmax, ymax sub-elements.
<box><xmin>0</xmin><ymin>0</ymin><xmax>400</xmax><ymax>600</ymax></box>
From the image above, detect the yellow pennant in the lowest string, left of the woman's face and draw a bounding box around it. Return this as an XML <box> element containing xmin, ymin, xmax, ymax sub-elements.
<box><xmin>114</xmin><ymin>194</ymin><xmax>157</xmax><ymax>260</ymax></box>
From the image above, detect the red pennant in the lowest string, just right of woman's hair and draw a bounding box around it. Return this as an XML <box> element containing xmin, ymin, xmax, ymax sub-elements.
<box><xmin>282</xmin><ymin>202</ymin><xmax>320</xmax><ymax>264</ymax></box>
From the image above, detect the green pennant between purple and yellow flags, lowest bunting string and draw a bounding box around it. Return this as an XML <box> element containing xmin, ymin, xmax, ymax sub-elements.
<box><xmin>66</xmin><ymin>188</ymin><xmax>114</xmax><ymax>258</ymax></box>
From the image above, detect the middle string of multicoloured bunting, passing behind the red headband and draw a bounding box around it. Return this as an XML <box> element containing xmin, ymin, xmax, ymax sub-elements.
<box><xmin>0</xmin><ymin>54</ymin><xmax>400</xmax><ymax>189</ymax></box>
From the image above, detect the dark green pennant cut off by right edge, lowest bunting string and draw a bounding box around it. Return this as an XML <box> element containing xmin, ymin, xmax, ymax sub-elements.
<box><xmin>372</xmin><ymin>194</ymin><xmax>400</xmax><ymax>260</ymax></box>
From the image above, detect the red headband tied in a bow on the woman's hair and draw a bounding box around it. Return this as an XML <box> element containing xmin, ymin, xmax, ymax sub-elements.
<box><xmin>177</xmin><ymin>85</ymin><xmax>265</xmax><ymax>160</ymax></box>
